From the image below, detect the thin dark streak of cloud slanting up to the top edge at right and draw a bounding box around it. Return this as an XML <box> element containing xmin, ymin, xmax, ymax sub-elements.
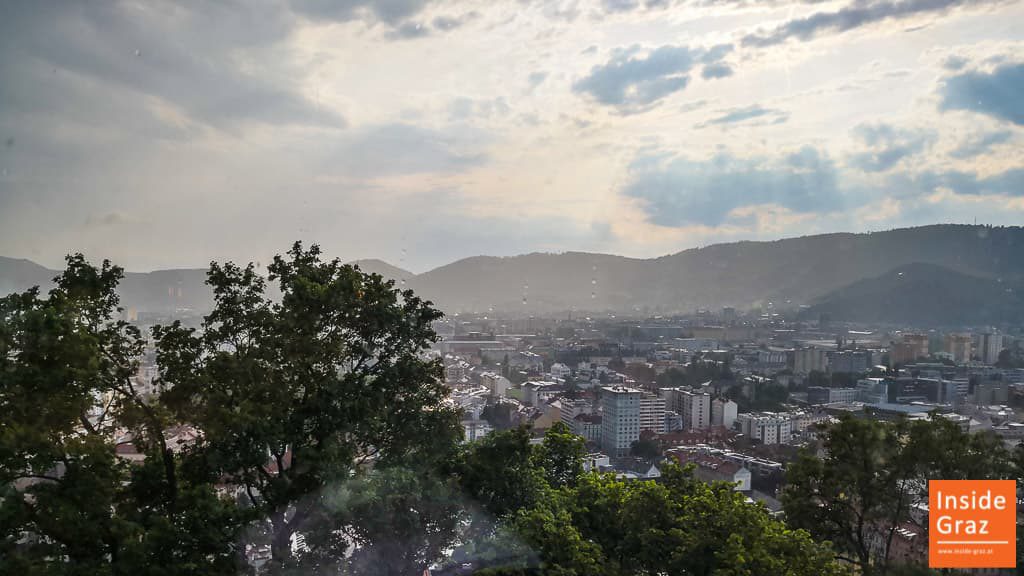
<box><xmin>741</xmin><ymin>0</ymin><xmax>1005</xmax><ymax>47</ymax></box>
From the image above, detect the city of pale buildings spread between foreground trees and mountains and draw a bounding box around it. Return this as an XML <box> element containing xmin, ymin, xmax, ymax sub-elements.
<box><xmin>434</xmin><ymin>308</ymin><xmax>1024</xmax><ymax>538</ymax></box>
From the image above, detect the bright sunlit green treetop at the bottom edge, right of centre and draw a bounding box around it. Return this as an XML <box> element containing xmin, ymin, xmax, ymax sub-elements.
<box><xmin>557</xmin><ymin>464</ymin><xmax>840</xmax><ymax>576</ymax></box>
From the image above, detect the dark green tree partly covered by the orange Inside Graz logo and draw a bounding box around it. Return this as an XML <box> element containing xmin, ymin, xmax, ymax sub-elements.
<box><xmin>781</xmin><ymin>415</ymin><xmax>1015</xmax><ymax>574</ymax></box>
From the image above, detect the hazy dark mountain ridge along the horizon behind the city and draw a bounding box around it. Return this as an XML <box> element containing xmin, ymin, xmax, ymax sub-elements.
<box><xmin>0</xmin><ymin>224</ymin><xmax>1024</xmax><ymax>323</ymax></box>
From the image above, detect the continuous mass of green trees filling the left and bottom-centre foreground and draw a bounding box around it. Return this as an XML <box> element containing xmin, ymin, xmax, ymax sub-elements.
<box><xmin>0</xmin><ymin>248</ymin><xmax>888</xmax><ymax>576</ymax></box>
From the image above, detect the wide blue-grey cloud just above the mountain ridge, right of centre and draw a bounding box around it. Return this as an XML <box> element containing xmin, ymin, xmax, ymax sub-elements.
<box><xmin>622</xmin><ymin>147</ymin><xmax>843</xmax><ymax>227</ymax></box>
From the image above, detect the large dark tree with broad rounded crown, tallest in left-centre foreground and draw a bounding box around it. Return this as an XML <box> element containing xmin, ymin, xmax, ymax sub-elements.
<box><xmin>154</xmin><ymin>243</ymin><xmax>461</xmax><ymax>571</ymax></box>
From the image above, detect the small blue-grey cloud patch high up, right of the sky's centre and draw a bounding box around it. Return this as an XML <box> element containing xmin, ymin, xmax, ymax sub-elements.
<box><xmin>572</xmin><ymin>45</ymin><xmax>731</xmax><ymax>114</ymax></box>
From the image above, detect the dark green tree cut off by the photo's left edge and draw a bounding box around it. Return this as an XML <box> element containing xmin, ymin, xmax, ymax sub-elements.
<box><xmin>0</xmin><ymin>254</ymin><xmax>243</xmax><ymax>574</ymax></box>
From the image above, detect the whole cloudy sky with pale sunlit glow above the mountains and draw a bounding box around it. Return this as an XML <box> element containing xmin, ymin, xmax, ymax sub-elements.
<box><xmin>0</xmin><ymin>0</ymin><xmax>1024</xmax><ymax>273</ymax></box>
